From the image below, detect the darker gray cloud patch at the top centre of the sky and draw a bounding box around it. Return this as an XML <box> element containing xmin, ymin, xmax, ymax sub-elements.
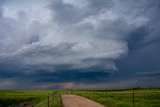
<box><xmin>48</xmin><ymin>0</ymin><xmax>113</xmax><ymax>25</ymax></box>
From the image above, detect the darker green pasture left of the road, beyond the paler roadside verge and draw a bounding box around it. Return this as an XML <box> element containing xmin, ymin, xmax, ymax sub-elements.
<box><xmin>0</xmin><ymin>90</ymin><xmax>53</xmax><ymax>107</ymax></box>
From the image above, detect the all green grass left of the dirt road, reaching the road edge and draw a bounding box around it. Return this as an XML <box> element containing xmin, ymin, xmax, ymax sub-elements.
<box><xmin>0</xmin><ymin>90</ymin><xmax>61</xmax><ymax>107</ymax></box>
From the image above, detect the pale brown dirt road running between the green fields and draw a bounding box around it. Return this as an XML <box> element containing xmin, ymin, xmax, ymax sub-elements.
<box><xmin>62</xmin><ymin>95</ymin><xmax>104</xmax><ymax>107</ymax></box>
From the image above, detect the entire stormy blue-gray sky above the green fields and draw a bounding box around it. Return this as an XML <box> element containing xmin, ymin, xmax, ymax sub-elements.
<box><xmin>0</xmin><ymin>0</ymin><xmax>160</xmax><ymax>89</ymax></box>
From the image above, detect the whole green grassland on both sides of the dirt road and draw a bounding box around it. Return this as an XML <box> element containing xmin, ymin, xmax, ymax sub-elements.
<box><xmin>0</xmin><ymin>88</ymin><xmax>160</xmax><ymax>107</ymax></box>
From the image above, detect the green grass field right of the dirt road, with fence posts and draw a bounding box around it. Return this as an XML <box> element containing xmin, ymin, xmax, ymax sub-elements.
<box><xmin>71</xmin><ymin>89</ymin><xmax>160</xmax><ymax>107</ymax></box>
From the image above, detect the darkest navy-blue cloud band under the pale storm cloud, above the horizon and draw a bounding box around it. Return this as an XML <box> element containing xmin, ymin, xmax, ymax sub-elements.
<box><xmin>31</xmin><ymin>70</ymin><xmax>111</xmax><ymax>84</ymax></box>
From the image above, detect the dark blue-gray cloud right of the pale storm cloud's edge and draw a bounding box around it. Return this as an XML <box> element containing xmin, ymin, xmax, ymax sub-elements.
<box><xmin>118</xmin><ymin>1</ymin><xmax>160</xmax><ymax>75</ymax></box>
